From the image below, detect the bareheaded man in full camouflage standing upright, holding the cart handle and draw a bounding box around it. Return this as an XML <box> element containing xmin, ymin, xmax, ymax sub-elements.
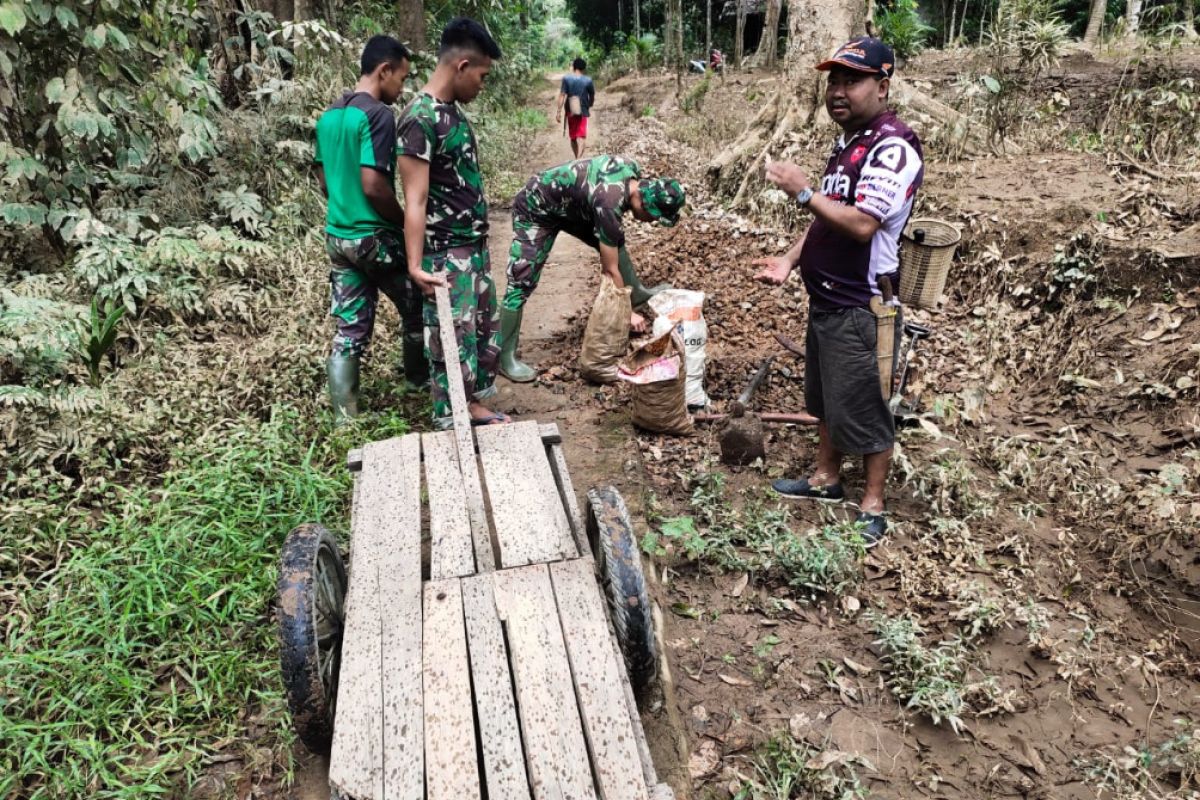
<box><xmin>396</xmin><ymin>17</ymin><xmax>509</xmax><ymax>427</ymax></box>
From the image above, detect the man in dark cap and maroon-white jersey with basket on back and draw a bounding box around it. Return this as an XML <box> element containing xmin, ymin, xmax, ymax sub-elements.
<box><xmin>755</xmin><ymin>36</ymin><xmax>924</xmax><ymax>547</ymax></box>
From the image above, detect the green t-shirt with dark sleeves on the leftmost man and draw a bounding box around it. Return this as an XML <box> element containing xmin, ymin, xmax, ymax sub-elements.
<box><xmin>316</xmin><ymin>91</ymin><xmax>397</xmax><ymax>239</ymax></box>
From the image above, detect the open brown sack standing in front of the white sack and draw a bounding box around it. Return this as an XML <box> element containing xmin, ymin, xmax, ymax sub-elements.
<box><xmin>620</xmin><ymin>327</ymin><xmax>692</xmax><ymax>437</ymax></box>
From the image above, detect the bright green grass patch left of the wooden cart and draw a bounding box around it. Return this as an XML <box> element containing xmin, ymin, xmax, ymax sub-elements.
<box><xmin>0</xmin><ymin>407</ymin><xmax>407</xmax><ymax>798</ymax></box>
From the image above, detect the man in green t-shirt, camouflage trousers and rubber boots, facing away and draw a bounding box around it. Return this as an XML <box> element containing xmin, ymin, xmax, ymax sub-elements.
<box><xmin>316</xmin><ymin>36</ymin><xmax>428</xmax><ymax>423</ymax></box>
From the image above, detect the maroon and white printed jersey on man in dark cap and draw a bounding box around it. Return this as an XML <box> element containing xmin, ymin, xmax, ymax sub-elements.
<box><xmin>800</xmin><ymin>110</ymin><xmax>925</xmax><ymax>309</ymax></box>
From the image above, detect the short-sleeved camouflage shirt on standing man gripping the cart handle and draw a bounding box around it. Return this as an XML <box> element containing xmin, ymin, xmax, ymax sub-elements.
<box><xmin>396</xmin><ymin>92</ymin><xmax>487</xmax><ymax>252</ymax></box>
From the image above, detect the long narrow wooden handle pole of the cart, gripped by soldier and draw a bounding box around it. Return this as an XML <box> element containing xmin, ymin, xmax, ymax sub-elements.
<box><xmin>434</xmin><ymin>287</ymin><xmax>494</xmax><ymax>572</ymax></box>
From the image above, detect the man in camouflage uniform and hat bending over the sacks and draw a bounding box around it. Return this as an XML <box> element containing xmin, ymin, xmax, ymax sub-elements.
<box><xmin>500</xmin><ymin>156</ymin><xmax>685</xmax><ymax>383</ymax></box>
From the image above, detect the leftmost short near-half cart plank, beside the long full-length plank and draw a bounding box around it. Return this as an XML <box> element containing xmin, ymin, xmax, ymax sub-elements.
<box><xmin>416</xmin><ymin>578</ymin><xmax>481</xmax><ymax>800</ymax></box>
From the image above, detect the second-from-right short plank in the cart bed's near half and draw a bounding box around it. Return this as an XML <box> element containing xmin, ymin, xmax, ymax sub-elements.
<box><xmin>492</xmin><ymin>563</ymin><xmax>595</xmax><ymax>800</ymax></box>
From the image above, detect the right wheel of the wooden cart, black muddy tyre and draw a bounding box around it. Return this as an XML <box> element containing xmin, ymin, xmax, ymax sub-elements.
<box><xmin>587</xmin><ymin>486</ymin><xmax>658</xmax><ymax>696</ymax></box>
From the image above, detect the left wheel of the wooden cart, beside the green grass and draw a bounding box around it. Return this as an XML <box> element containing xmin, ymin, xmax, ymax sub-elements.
<box><xmin>278</xmin><ymin>523</ymin><xmax>346</xmax><ymax>754</ymax></box>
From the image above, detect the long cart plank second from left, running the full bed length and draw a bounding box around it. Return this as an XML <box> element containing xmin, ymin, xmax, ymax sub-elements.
<box><xmin>376</xmin><ymin>433</ymin><xmax>425</xmax><ymax>800</ymax></box>
